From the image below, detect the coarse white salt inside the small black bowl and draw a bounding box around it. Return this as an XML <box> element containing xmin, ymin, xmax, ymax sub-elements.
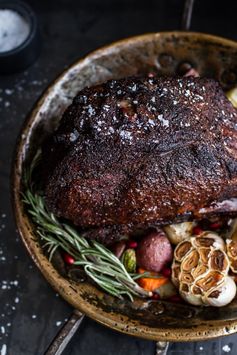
<box><xmin>0</xmin><ymin>9</ymin><xmax>30</xmax><ymax>53</ymax></box>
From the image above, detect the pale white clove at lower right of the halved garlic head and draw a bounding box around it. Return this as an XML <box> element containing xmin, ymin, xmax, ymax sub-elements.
<box><xmin>203</xmin><ymin>276</ymin><xmax>236</xmax><ymax>307</ymax></box>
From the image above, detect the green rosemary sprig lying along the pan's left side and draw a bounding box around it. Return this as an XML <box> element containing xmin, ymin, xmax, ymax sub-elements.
<box><xmin>22</xmin><ymin>151</ymin><xmax>151</xmax><ymax>300</ymax></box>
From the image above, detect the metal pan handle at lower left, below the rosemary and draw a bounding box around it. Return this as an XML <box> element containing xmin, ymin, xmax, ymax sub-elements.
<box><xmin>44</xmin><ymin>309</ymin><xmax>85</xmax><ymax>355</ymax></box>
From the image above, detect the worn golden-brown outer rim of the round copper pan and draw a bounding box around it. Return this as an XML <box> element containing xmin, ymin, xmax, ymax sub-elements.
<box><xmin>11</xmin><ymin>31</ymin><xmax>237</xmax><ymax>341</ymax></box>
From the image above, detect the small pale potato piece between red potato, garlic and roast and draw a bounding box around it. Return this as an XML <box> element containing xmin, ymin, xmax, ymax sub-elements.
<box><xmin>163</xmin><ymin>222</ymin><xmax>195</xmax><ymax>245</ymax></box>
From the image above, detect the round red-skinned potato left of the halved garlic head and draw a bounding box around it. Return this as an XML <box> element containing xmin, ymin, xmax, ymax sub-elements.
<box><xmin>136</xmin><ymin>230</ymin><xmax>173</xmax><ymax>272</ymax></box>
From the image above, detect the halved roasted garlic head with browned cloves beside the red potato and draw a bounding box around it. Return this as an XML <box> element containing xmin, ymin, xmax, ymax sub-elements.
<box><xmin>172</xmin><ymin>232</ymin><xmax>236</xmax><ymax>307</ymax></box>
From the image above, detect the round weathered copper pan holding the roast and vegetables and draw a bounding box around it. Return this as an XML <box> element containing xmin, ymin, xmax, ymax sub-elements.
<box><xmin>12</xmin><ymin>5</ymin><xmax>237</xmax><ymax>354</ymax></box>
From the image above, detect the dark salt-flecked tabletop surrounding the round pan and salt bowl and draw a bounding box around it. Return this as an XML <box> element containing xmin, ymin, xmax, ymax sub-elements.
<box><xmin>0</xmin><ymin>0</ymin><xmax>237</xmax><ymax>355</ymax></box>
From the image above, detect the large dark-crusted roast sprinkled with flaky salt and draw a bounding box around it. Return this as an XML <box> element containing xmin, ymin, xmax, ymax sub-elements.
<box><xmin>43</xmin><ymin>76</ymin><xmax>237</xmax><ymax>244</ymax></box>
